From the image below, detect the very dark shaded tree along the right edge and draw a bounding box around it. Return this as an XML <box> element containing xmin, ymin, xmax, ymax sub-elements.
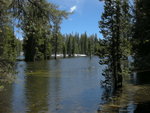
<box><xmin>133</xmin><ymin>0</ymin><xmax>150</xmax><ymax>70</ymax></box>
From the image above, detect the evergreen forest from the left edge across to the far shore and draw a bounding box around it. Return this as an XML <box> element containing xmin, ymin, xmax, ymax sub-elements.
<box><xmin>0</xmin><ymin>0</ymin><xmax>99</xmax><ymax>88</ymax></box>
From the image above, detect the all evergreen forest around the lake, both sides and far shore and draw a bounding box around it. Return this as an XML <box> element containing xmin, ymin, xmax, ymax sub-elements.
<box><xmin>0</xmin><ymin>0</ymin><xmax>150</xmax><ymax>112</ymax></box>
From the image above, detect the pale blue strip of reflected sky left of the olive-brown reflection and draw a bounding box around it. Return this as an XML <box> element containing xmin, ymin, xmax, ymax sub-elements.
<box><xmin>12</xmin><ymin>61</ymin><xmax>26</xmax><ymax>113</ymax></box>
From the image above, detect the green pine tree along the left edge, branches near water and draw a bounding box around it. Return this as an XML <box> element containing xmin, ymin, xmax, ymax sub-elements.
<box><xmin>0</xmin><ymin>0</ymin><xmax>16</xmax><ymax>87</ymax></box>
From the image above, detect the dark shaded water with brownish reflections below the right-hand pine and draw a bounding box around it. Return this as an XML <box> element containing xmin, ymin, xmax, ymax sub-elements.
<box><xmin>98</xmin><ymin>72</ymin><xmax>150</xmax><ymax>113</ymax></box>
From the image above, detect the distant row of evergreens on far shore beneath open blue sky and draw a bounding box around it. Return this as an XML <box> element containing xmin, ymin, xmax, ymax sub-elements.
<box><xmin>51</xmin><ymin>33</ymin><xmax>100</xmax><ymax>57</ymax></box>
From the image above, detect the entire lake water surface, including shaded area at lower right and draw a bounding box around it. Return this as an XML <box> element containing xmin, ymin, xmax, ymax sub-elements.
<box><xmin>0</xmin><ymin>57</ymin><xmax>150</xmax><ymax>113</ymax></box>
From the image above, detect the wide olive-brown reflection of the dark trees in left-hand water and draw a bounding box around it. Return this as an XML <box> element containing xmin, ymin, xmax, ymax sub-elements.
<box><xmin>25</xmin><ymin>62</ymin><xmax>49</xmax><ymax>113</ymax></box>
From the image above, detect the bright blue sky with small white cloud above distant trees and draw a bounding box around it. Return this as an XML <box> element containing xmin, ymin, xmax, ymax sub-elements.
<box><xmin>49</xmin><ymin>0</ymin><xmax>103</xmax><ymax>37</ymax></box>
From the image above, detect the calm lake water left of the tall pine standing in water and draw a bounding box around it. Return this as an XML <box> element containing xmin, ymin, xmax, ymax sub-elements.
<box><xmin>0</xmin><ymin>57</ymin><xmax>103</xmax><ymax>113</ymax></box>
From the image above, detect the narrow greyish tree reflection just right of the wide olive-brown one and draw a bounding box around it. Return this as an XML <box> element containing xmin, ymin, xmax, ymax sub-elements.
<box><xmin>48</xmin><ymin>59</ymin><xmax>62</xmax><ymax>112</ymax></box>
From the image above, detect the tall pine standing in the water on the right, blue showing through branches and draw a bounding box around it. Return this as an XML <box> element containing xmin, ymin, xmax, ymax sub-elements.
<box><xmin>99</xmin><ymin>0</ymin><xmax>132</xmax><ymax>89</ymax></box>
